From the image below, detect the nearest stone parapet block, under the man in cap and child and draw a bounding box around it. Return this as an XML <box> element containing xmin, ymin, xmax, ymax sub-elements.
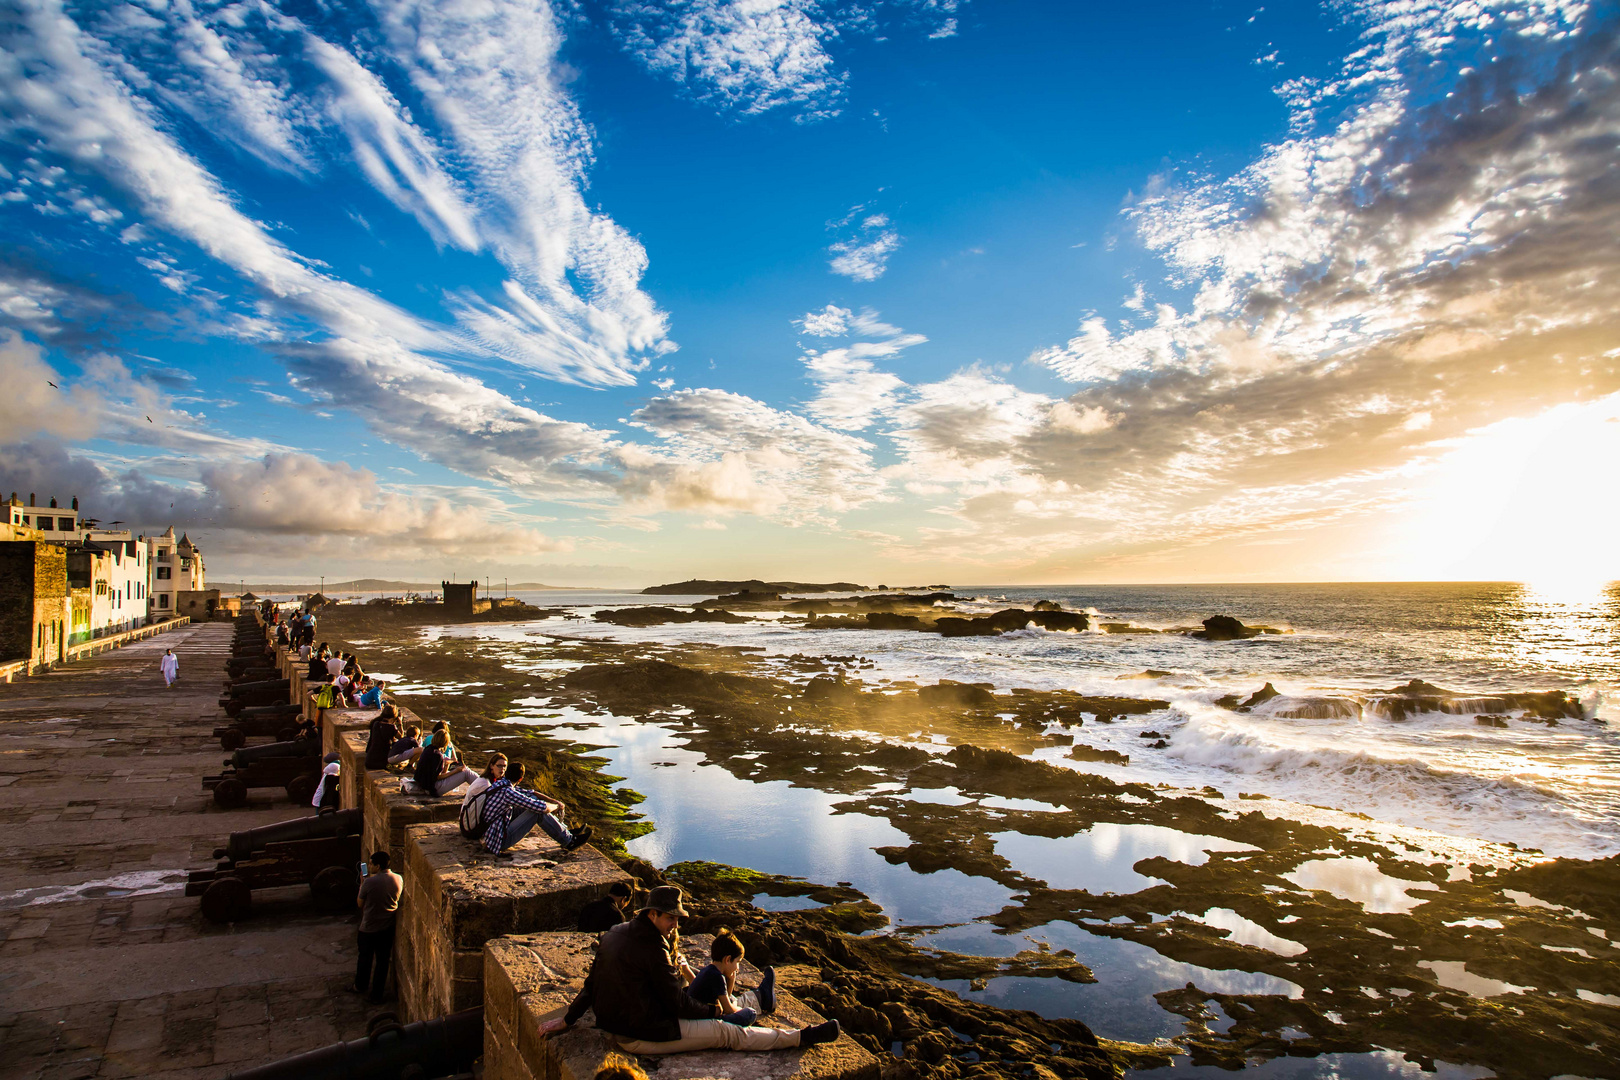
<box><xmin>484</xmin><ymin>933</ymin><xmax>880</xmax><ymax>1080</ymax></box>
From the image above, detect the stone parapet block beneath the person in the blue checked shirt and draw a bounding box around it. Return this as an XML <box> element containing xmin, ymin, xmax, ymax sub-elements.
<box><xmin>394</xmin><ymin>821</ymin><xmax>630</xmax><ymax>1020</ymax></box>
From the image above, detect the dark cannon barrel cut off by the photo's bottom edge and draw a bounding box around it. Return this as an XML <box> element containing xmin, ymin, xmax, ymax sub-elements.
<box><xmin>225</xmin><ymin>1007</ymin><xmax>484</xmax><ymax>1080</ymax></box>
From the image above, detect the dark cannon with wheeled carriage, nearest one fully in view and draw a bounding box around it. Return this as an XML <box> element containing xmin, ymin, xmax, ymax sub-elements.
<box><xmin>186</xmin><ymin>810</ymin><xmax>361</xmax><ymax>923</ymax></box>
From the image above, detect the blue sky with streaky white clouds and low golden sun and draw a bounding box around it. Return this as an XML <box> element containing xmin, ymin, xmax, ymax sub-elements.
<box><xmin>0</xmin><ymin>0</ymin><xmax>1620</xmax><ymax>585</ymax></box>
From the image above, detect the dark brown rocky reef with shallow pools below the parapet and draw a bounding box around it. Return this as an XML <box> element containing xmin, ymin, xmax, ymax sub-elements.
<box><xmin>306</xmin><ymin>609</ymin><xmax>1620</xmax><ymax>1080</ymax></box>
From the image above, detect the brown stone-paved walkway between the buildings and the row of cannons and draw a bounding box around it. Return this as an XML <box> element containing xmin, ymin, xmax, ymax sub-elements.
<box><xmin>0</xmin><ymin>623</ymin><xmax>368</xmax><ymax>1080</ymax></box>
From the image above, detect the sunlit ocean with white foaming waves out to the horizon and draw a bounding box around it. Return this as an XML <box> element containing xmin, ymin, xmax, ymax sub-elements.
<box><xmin>476</xmin><ymin>583</ymin><xmax>1620</xmax><ymax>858</ymax></box>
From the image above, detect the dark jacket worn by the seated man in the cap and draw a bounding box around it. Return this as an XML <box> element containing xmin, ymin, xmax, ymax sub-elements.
<box><xmin>565</xmin><ymin>912</ymin><xmax>719</xmax><ymax>1043</ymax></box>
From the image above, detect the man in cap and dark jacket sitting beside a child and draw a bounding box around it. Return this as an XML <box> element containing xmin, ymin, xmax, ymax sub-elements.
<box><xmin>554</xmin><ymin>886</ymin><xmax>839</xmax><ymax>1054</ymax></box>
